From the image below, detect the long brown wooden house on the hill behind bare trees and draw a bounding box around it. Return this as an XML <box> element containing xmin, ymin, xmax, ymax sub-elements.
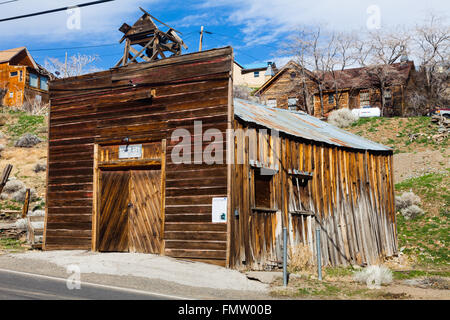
<box><xmin>256</xmin><ymin>61</ymin><xmax>415</xmax><ymax>117</ymax></box>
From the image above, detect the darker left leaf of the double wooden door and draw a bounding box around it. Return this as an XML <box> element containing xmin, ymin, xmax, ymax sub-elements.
<box><xmin>98</xmin><ymin>171</ymin><xmax>130</xmax><ymax>252</ymax></box>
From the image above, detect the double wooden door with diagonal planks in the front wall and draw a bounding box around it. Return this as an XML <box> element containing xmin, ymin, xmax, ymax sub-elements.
<box><xmin>98</xmin><ymin>169</ymin><xmax>163</xmax><ymax>254</ymax></box>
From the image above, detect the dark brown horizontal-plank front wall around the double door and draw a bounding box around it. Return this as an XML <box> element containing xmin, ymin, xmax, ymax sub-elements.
<box><xmin>46</xmin><ymin>47</ymin><xmax>233</xmax><ymax>265</ymax></box>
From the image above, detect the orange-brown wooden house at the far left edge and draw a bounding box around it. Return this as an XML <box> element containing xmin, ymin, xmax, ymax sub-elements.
<box><xmin>0</xmin><ymin>47</ymin><xmax>51</xmax><ymax>107</ymax></box>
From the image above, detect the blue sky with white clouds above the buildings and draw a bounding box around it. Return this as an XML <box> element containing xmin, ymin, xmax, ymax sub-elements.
<box><xmin>0</xmin><ymin>0</ymin><xmax>450</xmax><ymax>69</ymax></box>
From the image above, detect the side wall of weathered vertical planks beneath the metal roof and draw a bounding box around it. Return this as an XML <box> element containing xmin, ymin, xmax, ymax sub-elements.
<box><xmin>230</xmin><ymin>120</ymin><xmax>397</xmax><ymax>269</ymax></box>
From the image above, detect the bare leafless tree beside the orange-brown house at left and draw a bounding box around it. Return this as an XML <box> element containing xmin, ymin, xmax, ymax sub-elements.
<box><xmin>45</xmin><ymin>53</ymin><xmax>100</xmax><ymax>78</ymax></box>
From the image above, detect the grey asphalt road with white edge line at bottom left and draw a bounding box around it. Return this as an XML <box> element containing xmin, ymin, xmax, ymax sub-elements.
<box><xmin>0</xmin><ymin>270</ymin><xmax>185</xmax><ymax>300</ymax></box>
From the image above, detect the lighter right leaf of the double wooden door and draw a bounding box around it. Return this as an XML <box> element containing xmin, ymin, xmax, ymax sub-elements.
<box><xmin>129</xmin><ymin>170</ymin><xmax>163</xmax><ymax>254</ymax></box>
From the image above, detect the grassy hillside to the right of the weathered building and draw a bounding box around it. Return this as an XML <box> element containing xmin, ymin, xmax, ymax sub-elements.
<box><xmin>348</xmin><ymin>117</ymin><xmax>450</xmax><ymax>268</ymax></box>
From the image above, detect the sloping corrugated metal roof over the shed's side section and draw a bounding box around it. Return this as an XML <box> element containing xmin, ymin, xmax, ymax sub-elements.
<box><xmin>234</xmin><ymin>98</ymin><xmax>392</xmax><ymax>151</ymax></box>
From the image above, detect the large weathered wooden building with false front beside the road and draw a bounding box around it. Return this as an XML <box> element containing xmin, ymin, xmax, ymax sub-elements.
<box><xmin>44</xmin><ymin>47</ymin><xmax>397</xmax><ymax>269</ymax></box>
